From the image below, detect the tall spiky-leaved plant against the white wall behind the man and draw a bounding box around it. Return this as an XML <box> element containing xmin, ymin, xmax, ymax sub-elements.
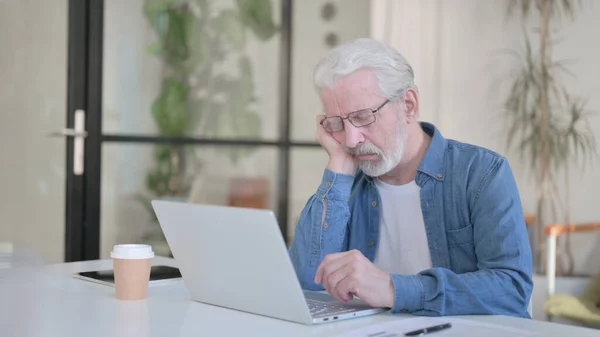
<box><xmin>504</xmin><ymin>0</ymin><xmax>596</xmax><ymax>274</ymax></box>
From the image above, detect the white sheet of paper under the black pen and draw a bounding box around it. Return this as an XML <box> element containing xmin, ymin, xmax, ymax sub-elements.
<box><xmin>338</xmin><ymin>317</ymin><xmax>540</xmax><ymax>337</ymax></box>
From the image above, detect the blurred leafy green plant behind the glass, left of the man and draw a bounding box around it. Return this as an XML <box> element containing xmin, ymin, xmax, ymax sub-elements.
<box><xmin>139</xmin><ymin>0</ymin><xmax>278</xmax><ymax>253</ymax></box>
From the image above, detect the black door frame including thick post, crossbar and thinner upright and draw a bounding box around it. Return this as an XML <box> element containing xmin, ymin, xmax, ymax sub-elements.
<box><xmin>65</xmin><ymin>0</ymin><xmax>320</xmax><ymax>262</ymax></box>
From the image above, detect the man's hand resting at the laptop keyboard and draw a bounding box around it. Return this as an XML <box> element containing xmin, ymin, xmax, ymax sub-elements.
<box><xmin>315</xmin><ymin>250</ymin><xmax>394</xmax><ymax>308</ymax></box>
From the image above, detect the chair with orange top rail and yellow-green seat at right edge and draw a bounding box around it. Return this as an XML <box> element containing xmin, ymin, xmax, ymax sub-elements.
<box><xmin>544</xmin><ymin>223</ymin><xmax>600</xmax><ymax>329</ymax></box>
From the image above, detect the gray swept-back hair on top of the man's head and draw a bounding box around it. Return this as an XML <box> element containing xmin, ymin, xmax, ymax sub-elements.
<box><xmin>313</xmin><ymin>38</ymin><xmax>418</xmax><ymax>101</ymax></box>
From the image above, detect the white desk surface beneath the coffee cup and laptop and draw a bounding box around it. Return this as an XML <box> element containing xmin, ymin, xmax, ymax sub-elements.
<box><xmin>0</xmin><ymin>257</ymin><xmax>600</xmax><ymax>337</ymax></box>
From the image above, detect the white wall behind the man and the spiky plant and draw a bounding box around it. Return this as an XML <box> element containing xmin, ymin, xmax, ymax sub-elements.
<box><xmin>372</xmin><ymin>0</ymin><xmax>600</xmax><ymax>282</ymax></box>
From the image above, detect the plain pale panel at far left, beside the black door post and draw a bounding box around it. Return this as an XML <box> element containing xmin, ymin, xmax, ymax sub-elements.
<box><xmin>0</xmin><ymin>0</ymin><xmax>67</xmax><ymax>262</ymax></box>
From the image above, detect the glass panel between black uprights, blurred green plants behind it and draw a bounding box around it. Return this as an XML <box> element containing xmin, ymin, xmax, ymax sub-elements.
<box><xmin>95</xmin><ymin>0</ymin><xmax>304</xmax><ymax>258</ymax></box>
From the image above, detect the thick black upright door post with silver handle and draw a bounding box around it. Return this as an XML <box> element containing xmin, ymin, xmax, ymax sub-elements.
<box><xmin>64</xmin><ymin>0</ymin><xmax>103</xmax><ymax>262</ymax></box>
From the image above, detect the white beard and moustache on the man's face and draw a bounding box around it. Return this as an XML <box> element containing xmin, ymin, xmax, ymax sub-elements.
<box><xmin>344</xmin><ymin>124</ymin><xmax>407</xmax><ymax>177</ymax></box>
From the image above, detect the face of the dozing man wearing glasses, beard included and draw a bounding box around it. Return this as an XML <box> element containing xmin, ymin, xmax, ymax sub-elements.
<box><xmin>322</xmin><ymin>70</ymin><xmax>407</xmax><ymax>177</ymax></box>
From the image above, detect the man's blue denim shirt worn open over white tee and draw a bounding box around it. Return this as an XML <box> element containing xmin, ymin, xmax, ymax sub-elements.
<box><xmin>289</xmin><ymin>123</ymin><xmax>533</xmax><ymax>318</ymax></box>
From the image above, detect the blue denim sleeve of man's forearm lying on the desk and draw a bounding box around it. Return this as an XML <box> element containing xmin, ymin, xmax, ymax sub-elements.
<box><xmin>392</xmin><ymin>268</ymin><xmax>533</xmax><ymax>317</ymax></box>
